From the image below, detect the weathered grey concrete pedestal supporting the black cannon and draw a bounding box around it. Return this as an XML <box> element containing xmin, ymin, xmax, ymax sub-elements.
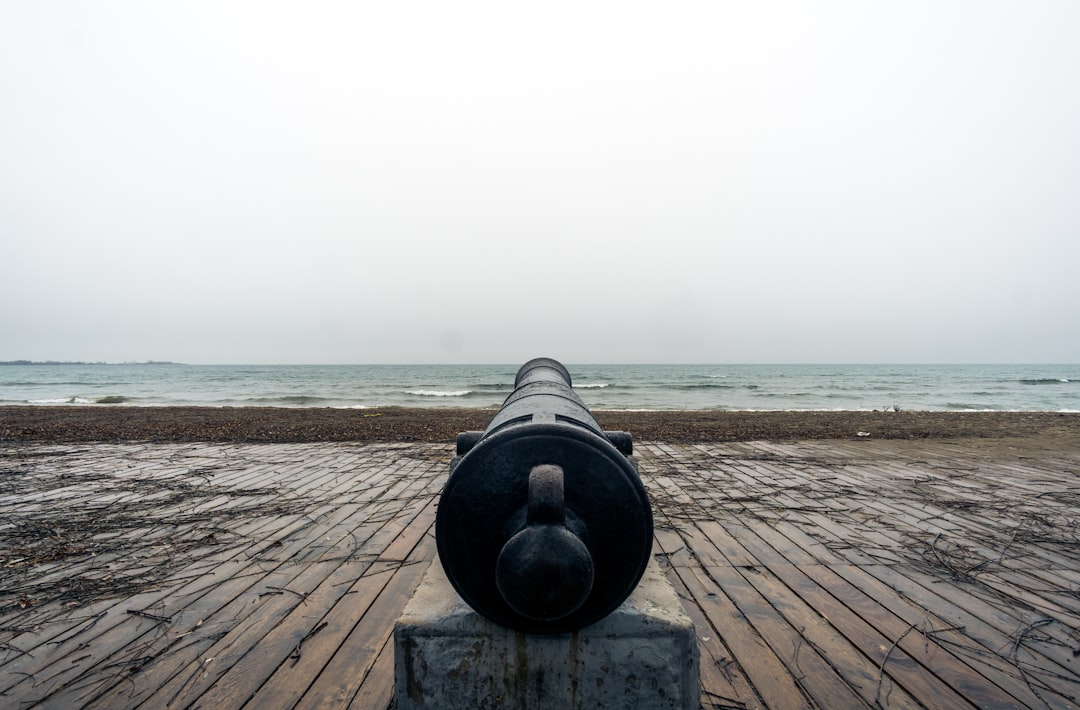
<box><xmin>394</xmin><ymin>559</ymin><xmax>701</xmax><ymax>710</ymax></box>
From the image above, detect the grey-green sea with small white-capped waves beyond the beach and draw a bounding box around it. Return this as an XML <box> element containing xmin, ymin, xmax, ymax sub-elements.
<box><xmin>0</xmin><ymin>363</ymin><xmax>1080</xmax><ymax>412</ymax></box>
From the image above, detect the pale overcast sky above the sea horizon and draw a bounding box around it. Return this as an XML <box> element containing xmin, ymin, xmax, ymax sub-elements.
<box><xmin>0</xmin><ymin>0</ymin><xmax>1080</xmax><ymax>363</ymax></box>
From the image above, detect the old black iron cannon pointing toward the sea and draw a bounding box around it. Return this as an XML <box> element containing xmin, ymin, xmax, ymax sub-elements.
<box><xmin>435</xmin><ymin>358</ymin><xmax>652</xmax><ymax>633</ymax></box>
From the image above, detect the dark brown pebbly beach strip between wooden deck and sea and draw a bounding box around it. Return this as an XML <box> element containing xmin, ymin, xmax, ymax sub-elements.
<box><xmin>0</xmin><ymin>405</ymin><xmax>1080</xmax><ymax>444</ymax></box>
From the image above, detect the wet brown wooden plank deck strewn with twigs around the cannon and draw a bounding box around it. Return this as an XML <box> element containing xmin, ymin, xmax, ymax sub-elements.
<box><xmin>0</xmin><ymin>440</ymin><xmax>1080</xmax><ymax>710</ymax></box>
